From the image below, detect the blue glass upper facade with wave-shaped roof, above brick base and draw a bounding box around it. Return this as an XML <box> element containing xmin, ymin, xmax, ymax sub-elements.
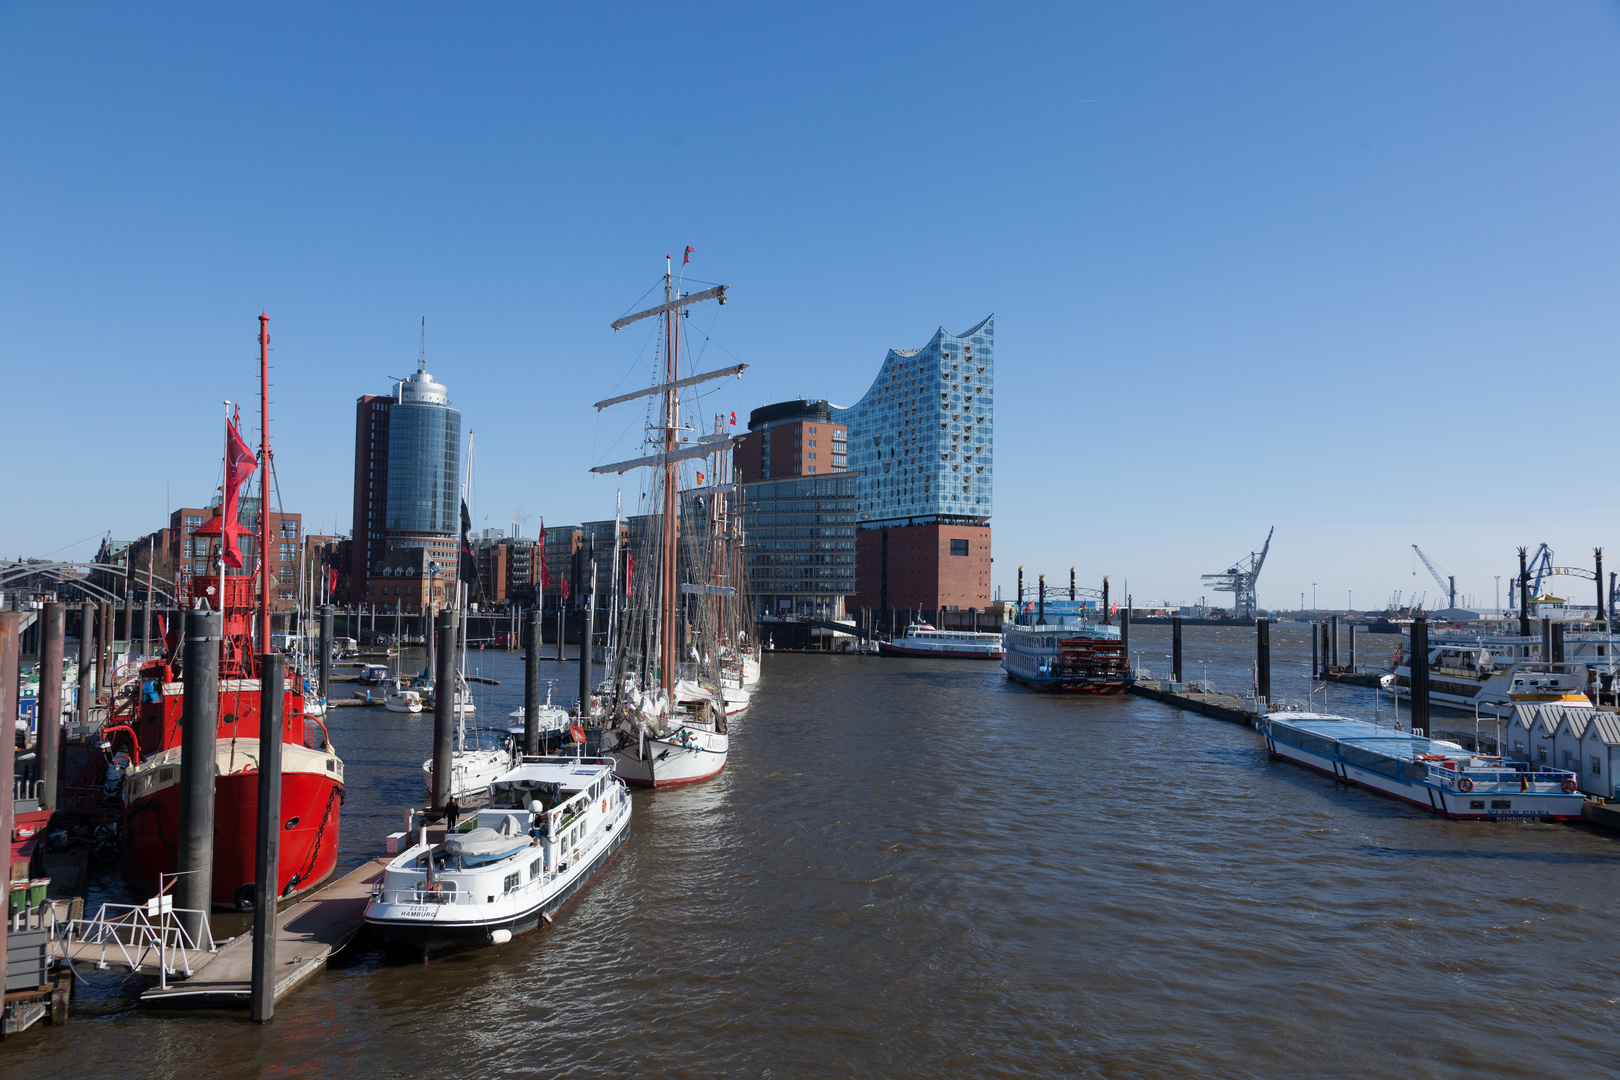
<box><xmin>833</xmin><ymin>316</ymin><xmax>996</xmax><ymax>528</ymax></box>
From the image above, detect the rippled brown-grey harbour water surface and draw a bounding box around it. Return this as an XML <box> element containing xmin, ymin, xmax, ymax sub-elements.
<box><xmin>0</xmin><ymin>627</ymin><xmax>1620</xmax><ymax>1077</ymax></box>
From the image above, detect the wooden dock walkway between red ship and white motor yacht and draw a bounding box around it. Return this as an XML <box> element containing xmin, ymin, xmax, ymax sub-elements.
<box><xmin>141</xmin><ymin>855</ymin><xmax>389</xmax><ymax>1009</ymax></box>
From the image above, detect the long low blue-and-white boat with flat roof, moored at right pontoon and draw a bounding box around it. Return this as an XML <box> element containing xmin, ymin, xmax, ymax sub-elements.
<box><xmin>1265</xmin><ymin>712</ymin><xmax>1586</xmax><ymax>821</ymax></box>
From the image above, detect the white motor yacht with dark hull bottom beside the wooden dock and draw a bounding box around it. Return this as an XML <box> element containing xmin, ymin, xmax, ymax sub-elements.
<box><xmin>365</xmin><ymin>758</ymin><xmax>630</xmax><ymax>957</ymax></box>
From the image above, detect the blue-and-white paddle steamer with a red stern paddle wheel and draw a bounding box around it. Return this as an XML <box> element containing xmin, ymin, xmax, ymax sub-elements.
<box><xmin>1001</xmin><ymin>601</ymin><xmax>1132</xmax><ymax>693</ymax></box>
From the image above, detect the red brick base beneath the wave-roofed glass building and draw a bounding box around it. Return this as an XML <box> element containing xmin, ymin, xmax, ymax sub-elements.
<box><xmin>846</xmin><ymin>525</ymin><xmax>990</xmax><ymax>610</ymax></box>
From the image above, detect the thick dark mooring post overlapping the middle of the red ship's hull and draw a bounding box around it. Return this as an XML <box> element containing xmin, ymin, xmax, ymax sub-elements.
<box><xmin>175</xmin><ymin>610</ymin><xmax>224</xmax><ymax>944</ymax></box>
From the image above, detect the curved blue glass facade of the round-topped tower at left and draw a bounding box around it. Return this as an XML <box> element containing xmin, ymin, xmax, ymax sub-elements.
<box><xmin>387</xmin><ymin>403</ymin><xmax>462</xmax><ymax>536</ymax></box>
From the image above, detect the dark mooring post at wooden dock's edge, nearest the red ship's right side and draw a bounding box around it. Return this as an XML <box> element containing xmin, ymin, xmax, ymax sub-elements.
<box><xmin>248</xmin><ymin>654</ymin><xmax>283</xmax><ymax>1023</ymax></box>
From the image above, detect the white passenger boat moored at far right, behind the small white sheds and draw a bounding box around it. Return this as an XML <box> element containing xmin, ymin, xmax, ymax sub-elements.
<box><xmin>1383</xmin><ymin>628</ymin><xmax>1620</xmax><ymax>717</ymax></box>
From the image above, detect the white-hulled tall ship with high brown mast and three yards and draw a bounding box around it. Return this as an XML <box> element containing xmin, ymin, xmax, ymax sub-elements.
<box><xmin>580</xmin><ymin>257</ymin><xmax>738</xmax><ymax>787</ymax></box>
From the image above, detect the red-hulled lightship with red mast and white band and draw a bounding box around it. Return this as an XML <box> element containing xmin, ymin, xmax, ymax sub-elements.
<box><xmin>109</xmin><ymin>316</ymin><xmax>343</xmax><ymax>907</ymax></box>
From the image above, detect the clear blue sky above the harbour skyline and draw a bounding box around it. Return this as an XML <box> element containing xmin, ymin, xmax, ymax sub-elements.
<box><xmin>0</xmin><ymin>3</ymin><xmax>1620</xmax><ymax>607</ymax></box>
